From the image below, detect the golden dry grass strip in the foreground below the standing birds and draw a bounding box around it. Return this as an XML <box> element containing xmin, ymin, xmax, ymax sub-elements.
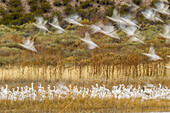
<box><xmin>0</xmin><ymin>98</ymin><xmax>170</xmax><ymax>112</ymax></box>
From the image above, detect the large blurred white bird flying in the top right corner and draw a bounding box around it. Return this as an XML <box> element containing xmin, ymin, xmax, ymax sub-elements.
<box><xmin>154</xmin><ymin>2</ymin><xmax>170</xmax><ymax>15</ymax></box>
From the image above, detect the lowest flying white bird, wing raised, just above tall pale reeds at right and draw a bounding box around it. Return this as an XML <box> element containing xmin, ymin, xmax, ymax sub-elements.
<box><xmin>142</xmin><ymin>46</ymin><xmax>162</xmax><ymax>61</ymax></box>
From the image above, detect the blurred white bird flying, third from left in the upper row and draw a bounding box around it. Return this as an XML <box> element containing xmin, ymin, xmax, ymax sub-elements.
<box><xmin>64</xmin><ymin>14</ymin><xmax>84</xmax><ymax>26</ymax></box>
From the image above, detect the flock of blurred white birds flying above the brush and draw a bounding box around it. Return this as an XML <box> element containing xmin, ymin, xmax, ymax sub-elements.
<box><xmin>17</xmin><ymin>0</ymin><xmax>170</xmax><ymax>61</ymax></box>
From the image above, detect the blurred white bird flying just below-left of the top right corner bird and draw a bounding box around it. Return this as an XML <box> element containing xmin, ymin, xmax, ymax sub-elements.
<box><xmin>142</xmin><ymin>8</ymin><xmax>163</xmax><ymax>22</ymax></box>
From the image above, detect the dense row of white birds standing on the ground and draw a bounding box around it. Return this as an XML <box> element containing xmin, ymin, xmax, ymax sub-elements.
<box><xmin>0</xmin><ymin>83</ymin><xmax>170</xmax><ymax>101</ymax></box>
